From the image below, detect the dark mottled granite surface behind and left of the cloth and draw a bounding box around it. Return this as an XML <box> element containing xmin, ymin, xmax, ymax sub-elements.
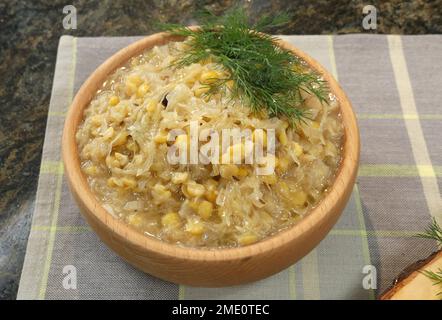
<box><xmin>0</xmin><ymin>0</ymin><xmax>442</xmax><ymax>299</ymax></box>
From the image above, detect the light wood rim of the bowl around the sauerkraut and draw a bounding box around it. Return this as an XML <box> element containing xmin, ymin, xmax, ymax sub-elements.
<box><xmin>62</xmin><ymin>32</ymin><xmax>360</xmax><ymax>261</ymax></box>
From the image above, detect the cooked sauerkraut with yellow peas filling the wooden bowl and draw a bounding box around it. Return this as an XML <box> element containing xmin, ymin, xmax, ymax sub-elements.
<box><xmin>77</xmin><ymin>42</ymin><xmax>343</xmax><ymax>247</ymax></box>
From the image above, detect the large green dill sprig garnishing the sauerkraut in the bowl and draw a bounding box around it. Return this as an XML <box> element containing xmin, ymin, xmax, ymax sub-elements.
<box><xmin>163</xmin><ymin>7</ymin><xmax>327</xmax><ymax>123</ymax></box>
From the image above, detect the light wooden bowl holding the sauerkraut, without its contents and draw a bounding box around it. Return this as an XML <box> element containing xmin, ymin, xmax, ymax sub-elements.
<box><xmin>62</xmin><ymin>33</ymin><xmax>360</xmax><ymax>287</ymax></box>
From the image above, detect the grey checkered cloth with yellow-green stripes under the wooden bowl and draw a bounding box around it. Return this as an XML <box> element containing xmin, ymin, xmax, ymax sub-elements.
<box><xmin>18</xmin><ymin>35</ymin><xmax>442</xmax><ymax>299</ymax></box>
